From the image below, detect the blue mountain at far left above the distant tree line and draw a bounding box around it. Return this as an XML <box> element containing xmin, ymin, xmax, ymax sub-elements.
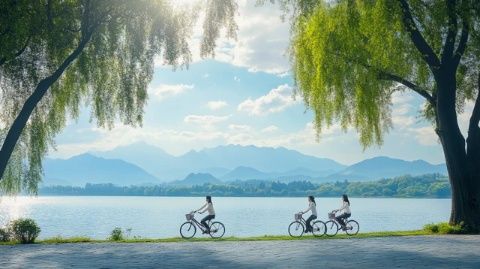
<box><xmin>43</xmin><ymin>154</ymin><xmax>159</xmax><ymax>186</ymax></box>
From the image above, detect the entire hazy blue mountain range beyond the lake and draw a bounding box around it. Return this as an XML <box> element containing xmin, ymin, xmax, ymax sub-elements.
<box><xmin>44</xmin><ymin>143</ymin><xmax>446</xmax><ymax>186</ymax></box>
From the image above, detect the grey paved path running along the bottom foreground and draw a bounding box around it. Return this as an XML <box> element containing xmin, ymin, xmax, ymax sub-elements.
<box><xmin>0</xmin><ymin>235</ymin><xmax>480</xmax><ymax>269</ymax></box>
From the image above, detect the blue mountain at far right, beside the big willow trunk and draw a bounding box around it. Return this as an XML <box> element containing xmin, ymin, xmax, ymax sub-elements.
<box><xmin>326</xmin><ymin>157</ymin><xmax>447</xmax><ymax>180</ymax></box>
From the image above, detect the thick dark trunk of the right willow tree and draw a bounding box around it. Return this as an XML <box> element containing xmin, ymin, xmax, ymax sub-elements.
<box><xmin>436</xmin><ymin>69</ymin><xmax>480</xmax><ymax>232</ymax></box>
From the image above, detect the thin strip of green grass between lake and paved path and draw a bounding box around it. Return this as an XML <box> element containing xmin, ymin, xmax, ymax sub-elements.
<box><xmin>10</xmin><ymin>230</ymin><xmax>433</xmax><ymax>244</ymax></box>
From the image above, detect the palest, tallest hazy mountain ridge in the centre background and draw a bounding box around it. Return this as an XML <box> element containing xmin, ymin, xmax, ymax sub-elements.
<box><xmin>94</xmin><ymin>143</ymin><xmax>345</xmax><ymax>182</ymax></box>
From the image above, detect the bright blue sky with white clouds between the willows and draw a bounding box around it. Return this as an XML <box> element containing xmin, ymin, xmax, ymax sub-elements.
<box><xmin>49</xmin><ymin>0</ymin><xmax>470</xmax><ymax>164</ymax></box>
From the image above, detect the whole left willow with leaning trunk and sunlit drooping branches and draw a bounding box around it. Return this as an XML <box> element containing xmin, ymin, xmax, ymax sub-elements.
<box><xmin>0</xmin><ymin>0</ymin><xmax>236</xmax><ymax>193</ymax></box>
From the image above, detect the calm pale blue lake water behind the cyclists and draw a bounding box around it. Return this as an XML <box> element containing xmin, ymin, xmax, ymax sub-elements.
<box><xmin>0</xmin><ymin>196</ymin><xmax>450</xmax><ymax>239</ymax></box>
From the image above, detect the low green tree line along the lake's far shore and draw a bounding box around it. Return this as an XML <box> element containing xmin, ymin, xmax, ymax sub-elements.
<box><xmin>40</xmin><ymin>174</ymin><xmax>451</xmax><ymax>198</ymax></box>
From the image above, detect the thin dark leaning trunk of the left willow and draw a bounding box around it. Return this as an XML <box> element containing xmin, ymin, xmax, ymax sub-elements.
<box><xmin>0</xmin><ymin>32</ymin><xmax>93</xmax><ymax>180</ymax></box>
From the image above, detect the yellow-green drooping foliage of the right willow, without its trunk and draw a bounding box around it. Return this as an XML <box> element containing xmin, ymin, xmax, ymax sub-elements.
<box><xmin>290</xmin><ymin>0</ymin><xmax>480</xmax><ymax>147</ymax></box>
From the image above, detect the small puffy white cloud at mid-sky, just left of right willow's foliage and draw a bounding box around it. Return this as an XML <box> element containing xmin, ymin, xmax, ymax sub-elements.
<box><xmin>238</xmin><ymin>84</ymin><xmax>298</xmax><ymax>115</ymax></box>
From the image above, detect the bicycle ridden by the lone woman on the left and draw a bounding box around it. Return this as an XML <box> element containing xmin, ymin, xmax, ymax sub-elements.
<box><xmin>180</xmin><ymin>211</ymin><xmax>225</xmax><ymax>239</ymax></box>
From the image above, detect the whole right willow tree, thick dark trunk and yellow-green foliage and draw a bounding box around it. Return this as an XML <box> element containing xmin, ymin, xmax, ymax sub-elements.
<box><xmin>286</xmin><ymin>0</ymin><xmax>480</xmax><ymax>231</ymax></box>
